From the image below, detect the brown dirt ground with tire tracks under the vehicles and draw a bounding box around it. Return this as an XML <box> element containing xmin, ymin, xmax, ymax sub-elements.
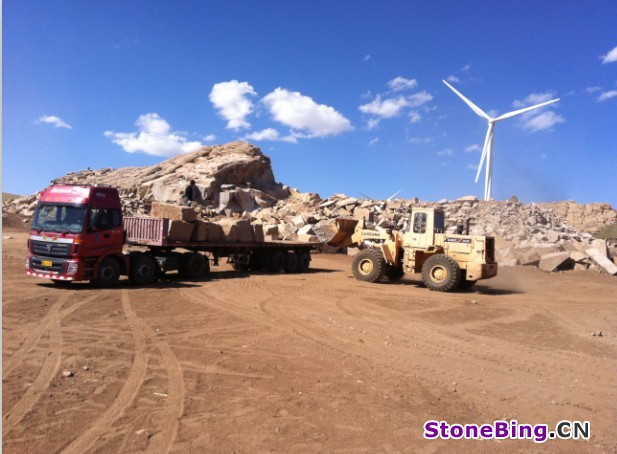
<box><xmin>2</xmin><ymin>229</ymin><xmax>617</xmax><ymax>453</ymax></box>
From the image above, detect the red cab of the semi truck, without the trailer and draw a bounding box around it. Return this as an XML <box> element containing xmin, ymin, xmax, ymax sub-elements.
<box><xmin>25</xmin><ymin>185</ymin><xmax>125</xmax><ymax>283</ymax></box>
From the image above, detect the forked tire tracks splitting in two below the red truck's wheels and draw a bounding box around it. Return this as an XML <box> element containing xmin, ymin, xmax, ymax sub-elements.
<box><xmin>63</xmin><ymin>289</ymin><xmax>184</xmax><ymax>454</ymax></box>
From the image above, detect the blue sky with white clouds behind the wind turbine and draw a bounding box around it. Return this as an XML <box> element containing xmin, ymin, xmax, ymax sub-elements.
<box><xmin>2</xmin><ymin>0</ymin><xmax>617</xmax><ymax>207</ymax></box>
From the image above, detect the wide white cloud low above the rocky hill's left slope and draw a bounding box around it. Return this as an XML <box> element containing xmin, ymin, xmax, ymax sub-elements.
<box><xmin>105</xmin><ymin>113</ymin><xmax>202</xmax><ymax>156</ymax></box>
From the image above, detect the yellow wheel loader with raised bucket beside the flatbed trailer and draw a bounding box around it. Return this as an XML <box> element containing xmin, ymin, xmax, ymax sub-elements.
<box><xmin>328</xmin><ymin>208</ymin><xmax>497</xmax><ymax>292</ymax></box>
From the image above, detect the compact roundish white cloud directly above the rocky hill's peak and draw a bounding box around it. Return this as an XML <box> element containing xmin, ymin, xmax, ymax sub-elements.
<box><xmin>210</xmin><ymin>80</ymin><xmax>257</xmax><ymax>131</ymax></box>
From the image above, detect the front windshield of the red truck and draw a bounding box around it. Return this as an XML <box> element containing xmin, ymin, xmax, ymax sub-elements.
<box><xmin>32</xmin><ymin>203</ymin><xmax>86</xmax><ymax>233</ymax></box>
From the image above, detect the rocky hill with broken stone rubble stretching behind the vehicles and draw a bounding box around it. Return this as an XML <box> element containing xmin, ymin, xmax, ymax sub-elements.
<box><xmin>3</xmin><ymin>141</ymin><xmax>617</xmax><ymax>274</ymax></box>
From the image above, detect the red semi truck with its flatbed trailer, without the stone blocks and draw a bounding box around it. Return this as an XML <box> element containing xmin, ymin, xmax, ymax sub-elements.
<box><xmin>25</xmin><ymin>185</ymin><xmax>315</xmax><ymax>287</ymax></box>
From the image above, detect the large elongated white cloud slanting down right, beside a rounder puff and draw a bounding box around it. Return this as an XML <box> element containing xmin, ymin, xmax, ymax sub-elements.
<box><xmin>262</xmin><ymin>87</ymin><xmax>352</xmax><ymax>138</ymax></box>
